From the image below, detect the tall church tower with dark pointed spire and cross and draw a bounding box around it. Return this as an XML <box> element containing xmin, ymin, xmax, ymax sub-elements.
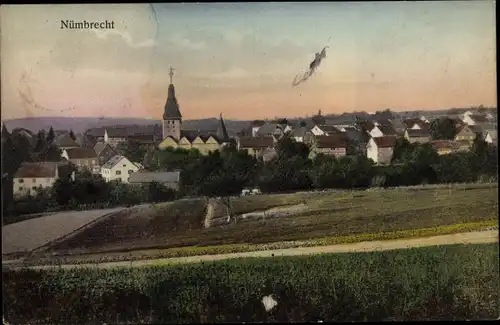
<box><xmin>162</xmin><ymin>67</ymin><xmax>182</xmax><ymax>140</ymax></box>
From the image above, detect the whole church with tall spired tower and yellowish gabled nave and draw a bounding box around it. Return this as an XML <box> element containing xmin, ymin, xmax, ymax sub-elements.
<box><xmin>158</xmin><ymin>68</ymin><xmax>230</xmax><ymax>155</ymax></box>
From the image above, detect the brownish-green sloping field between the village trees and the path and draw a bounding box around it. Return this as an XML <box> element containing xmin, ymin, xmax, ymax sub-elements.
<box><xmin>42</xmin><ymin>184</ymin><xmax>498</xmax><ymax>255</ymax></box>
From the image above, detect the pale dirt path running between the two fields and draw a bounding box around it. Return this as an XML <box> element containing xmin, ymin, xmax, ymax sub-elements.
<box><xmin>13</xmin><ymin>230</ymin><xmax>498</xmax><ymax>269</ymax></box>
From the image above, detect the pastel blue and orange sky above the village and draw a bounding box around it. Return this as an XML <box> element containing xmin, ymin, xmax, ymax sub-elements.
<box><xmin>0</xmin><ymin>1</ymin><xmax>496</xmax><ymax>119</ymax></box>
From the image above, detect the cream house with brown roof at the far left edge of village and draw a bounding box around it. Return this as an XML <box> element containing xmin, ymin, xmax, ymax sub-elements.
<box><xmin>13</xmin><ymin>162</ymin><xmax>59</xmax><ymax>197</ymax></box>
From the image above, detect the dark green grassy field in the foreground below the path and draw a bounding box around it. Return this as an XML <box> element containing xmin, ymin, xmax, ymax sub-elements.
<box><xmin>2</xmin><ymin>244</ymin><xmax>500</xmax><ymax>324</ymax></box>
